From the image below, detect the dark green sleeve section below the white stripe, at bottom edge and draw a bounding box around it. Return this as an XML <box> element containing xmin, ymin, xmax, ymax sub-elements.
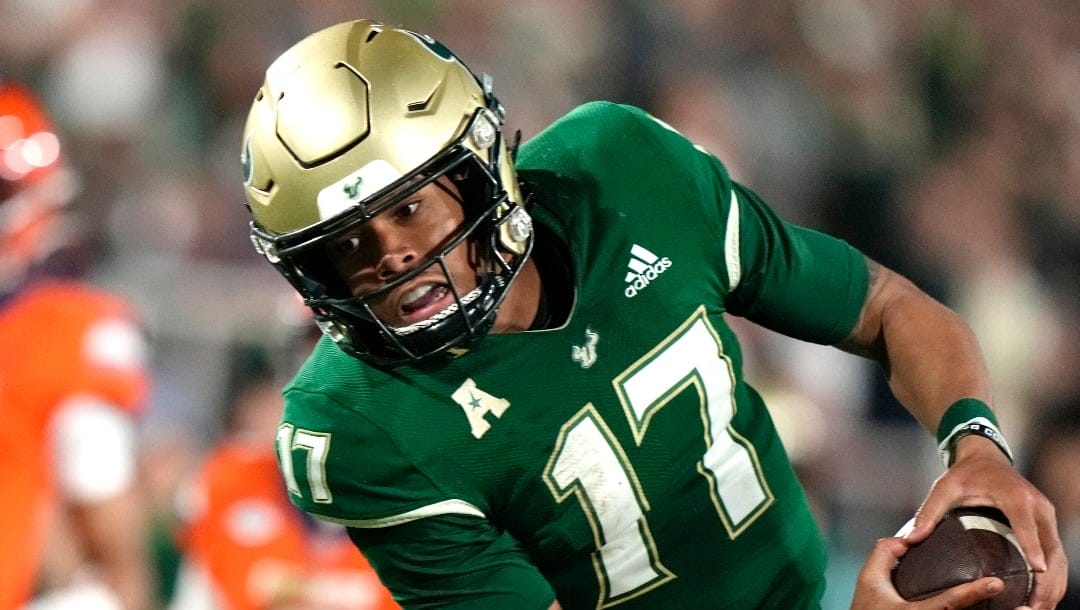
<box><xmin>349</xmin><ymin>515</ymin><xmax>555</xmax><ymax>610</ymax></box>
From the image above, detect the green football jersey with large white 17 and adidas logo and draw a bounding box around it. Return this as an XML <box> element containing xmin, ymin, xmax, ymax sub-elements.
<box><xmin>278</xmin><ymin>103</ymin><xmax>867</xmax><ymax>610</ymax></box>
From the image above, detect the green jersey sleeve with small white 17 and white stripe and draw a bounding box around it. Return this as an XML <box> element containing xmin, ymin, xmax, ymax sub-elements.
<box><xmin>278</xmin><ymin>388</ymin><xmax>554</xmax><ymax>609</ymax></box>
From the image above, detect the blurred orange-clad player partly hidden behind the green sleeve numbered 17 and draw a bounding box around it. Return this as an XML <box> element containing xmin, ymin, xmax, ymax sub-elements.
<box><xmin>170</xmin><ymin>343</ymin><xmax>400</xmax><ymax>610</ymax></box>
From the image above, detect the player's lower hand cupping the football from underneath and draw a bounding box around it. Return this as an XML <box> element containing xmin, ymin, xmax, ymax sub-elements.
<box><xmin>851</xmin><ymin>538</ymin><xmax>1005</xmax><ymax>610</ymax></box>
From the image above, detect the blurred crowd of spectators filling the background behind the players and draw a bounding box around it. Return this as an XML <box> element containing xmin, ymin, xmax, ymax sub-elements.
<box><xmin>0</xmin><ymin>0</ymin><xmax>1080</xmax><ymax>607</ymax></box>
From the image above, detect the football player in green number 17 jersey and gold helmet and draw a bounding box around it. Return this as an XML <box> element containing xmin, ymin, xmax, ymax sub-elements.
<box><xmin>242</xmin><ymin>21</ymin><xmax>1065</xmax><ymax>610</ymax></box>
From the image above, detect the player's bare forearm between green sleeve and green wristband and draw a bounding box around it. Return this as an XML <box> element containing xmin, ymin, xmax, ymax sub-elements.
<box><xmin>841</xmin><ymin>259</ymin><xmax>990</xmax><ymax>433</ymax></box>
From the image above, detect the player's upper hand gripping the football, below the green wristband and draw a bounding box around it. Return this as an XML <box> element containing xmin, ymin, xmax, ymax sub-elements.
<box><xmin>906</xmin><ymin>435</ymin><xmax>1068</xmax><ymax>610</ymax></box>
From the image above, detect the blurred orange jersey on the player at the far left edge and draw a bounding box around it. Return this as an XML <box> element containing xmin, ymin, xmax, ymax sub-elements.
<box><xmin>0</xmin><ymin>282</ymin><xmax>149</xmax><ymax>610</ymax></box>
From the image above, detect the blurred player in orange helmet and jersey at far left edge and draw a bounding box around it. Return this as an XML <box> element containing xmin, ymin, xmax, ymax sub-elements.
<box><xmin>0</xmin><ymin>81</ymin><xmax>151</xmax><ymax>610</ymax></box>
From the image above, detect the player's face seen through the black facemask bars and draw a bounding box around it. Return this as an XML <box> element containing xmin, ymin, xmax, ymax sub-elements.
<box><xmin>326</xmin><ymin>178</ymin><xmax>476</xmax><ymax>327</ymax></box>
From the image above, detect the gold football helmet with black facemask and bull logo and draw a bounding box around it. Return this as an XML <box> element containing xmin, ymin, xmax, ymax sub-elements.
<box><xmin>242</xmin><ymin>21</ymin><xmax>532</xmax><ymax>366</ymax></box>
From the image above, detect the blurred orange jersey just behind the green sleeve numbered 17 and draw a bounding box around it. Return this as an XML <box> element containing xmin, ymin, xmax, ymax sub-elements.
<box><xmin>179</xmin><ymin>439</ymin><xmax>400</xmax><ymax>610</ymax></box>
